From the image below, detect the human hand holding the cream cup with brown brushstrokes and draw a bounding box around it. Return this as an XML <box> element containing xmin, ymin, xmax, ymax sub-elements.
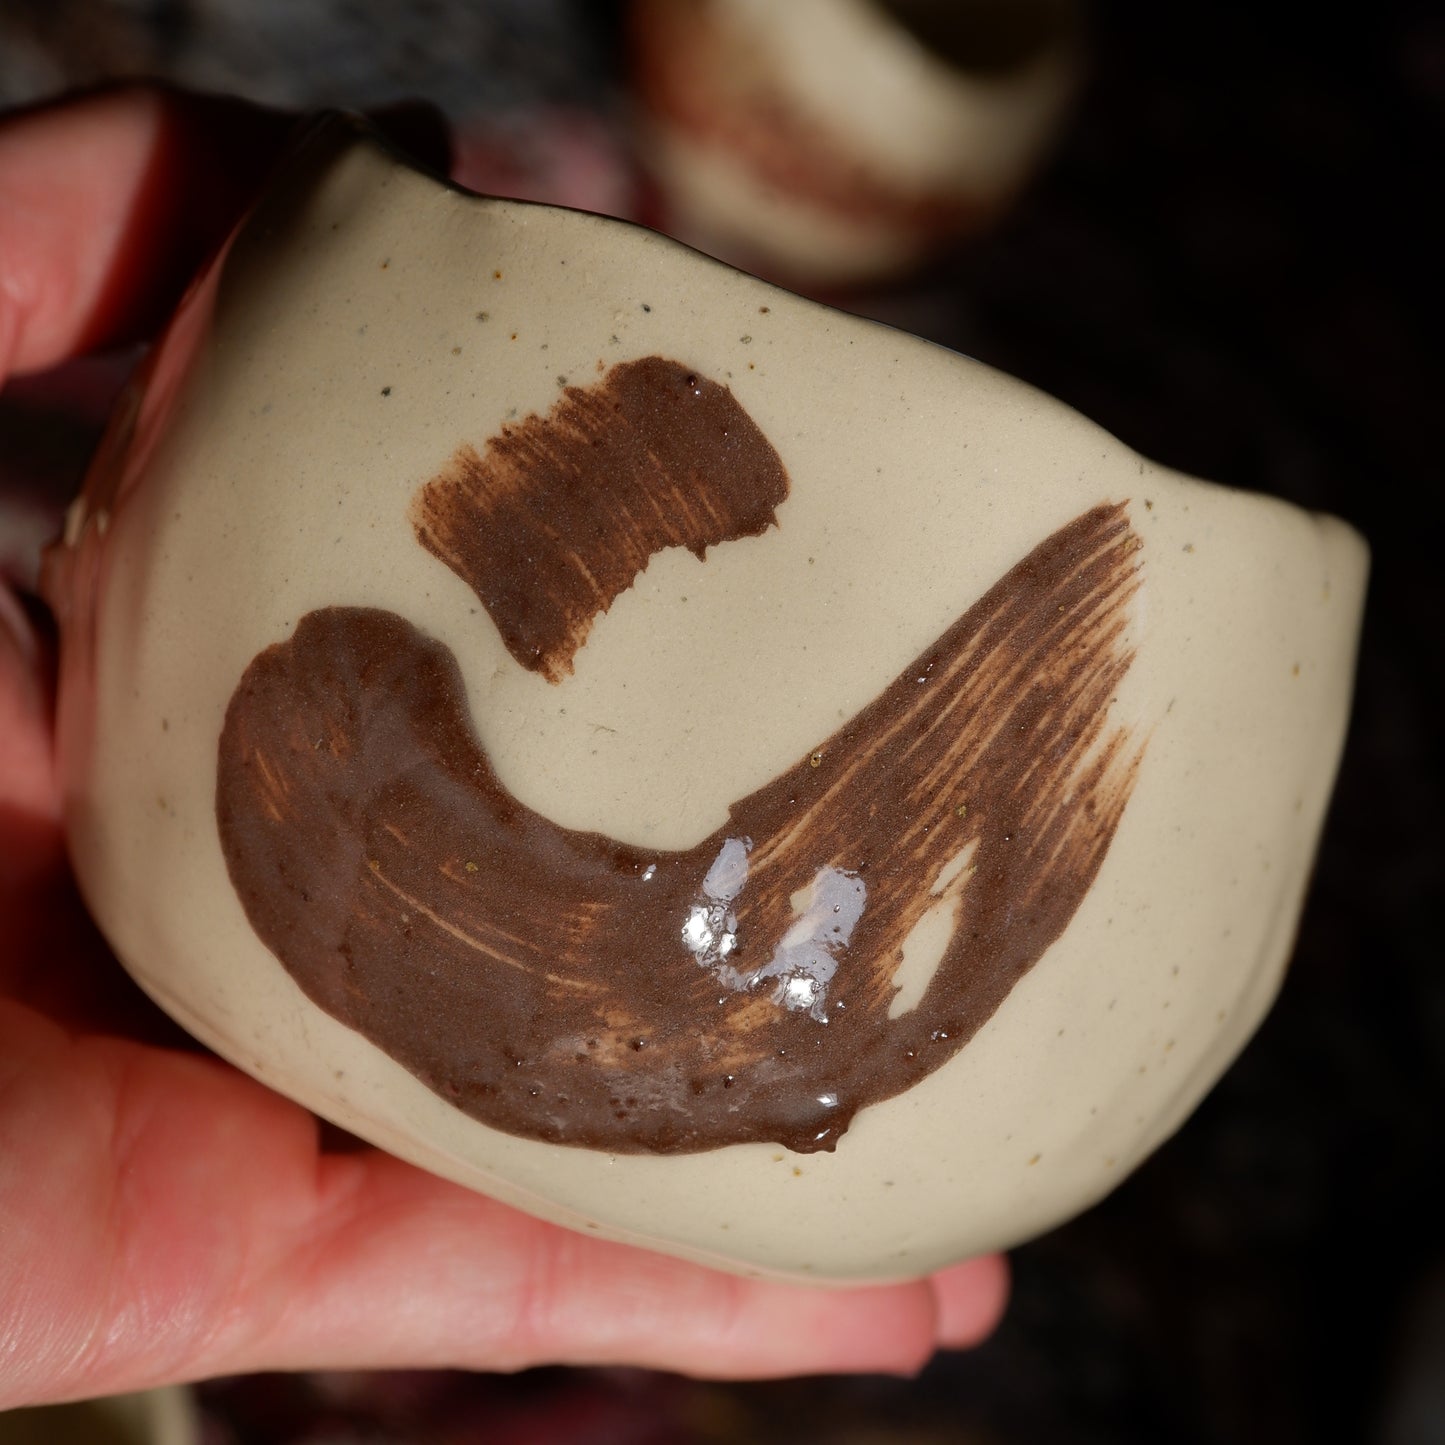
<box><xmin>0</xmin><ymin>90</ymin><xmax>1006</xmax><ymax>1409</ymax></box>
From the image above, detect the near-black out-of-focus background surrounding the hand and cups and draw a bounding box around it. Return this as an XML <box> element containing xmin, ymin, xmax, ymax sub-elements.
<box><xmin>0</xmin><ymin>0</ymin><xmax>1445</xmax><ymax>1445</ymax></box>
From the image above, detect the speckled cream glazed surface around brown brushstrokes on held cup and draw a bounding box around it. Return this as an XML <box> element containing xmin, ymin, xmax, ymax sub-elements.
<box><xmin>53</xmin><ymin>124</ymin><xmax>1366</xmax><ymax>1280</ymax></box>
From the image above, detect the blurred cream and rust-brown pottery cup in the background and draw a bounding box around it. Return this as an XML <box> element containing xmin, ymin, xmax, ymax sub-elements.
<box><xmin>629</xmin><ymin>0</ymin><xmax>1081</xmax><ymax>289</ymax></box>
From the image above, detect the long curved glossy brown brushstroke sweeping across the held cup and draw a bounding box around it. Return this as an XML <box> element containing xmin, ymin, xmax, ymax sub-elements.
<box><xmin>217</xmin><ymin>506</ymin><xmax>1139</xmax><ymax>1153</ymax></box>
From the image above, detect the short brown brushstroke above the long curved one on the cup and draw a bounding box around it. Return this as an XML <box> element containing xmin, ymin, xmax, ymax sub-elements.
<box><xmin>412</xmin><ymin>355</ymin><xmax>788</xmax><ymax>682</ymax></box>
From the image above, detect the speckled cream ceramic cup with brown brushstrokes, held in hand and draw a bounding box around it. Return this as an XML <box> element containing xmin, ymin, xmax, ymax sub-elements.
<box><xmin>39</xmin><ymin>118</ymin><xmax>1366</xmax><ymax>1280</ymax></box>
